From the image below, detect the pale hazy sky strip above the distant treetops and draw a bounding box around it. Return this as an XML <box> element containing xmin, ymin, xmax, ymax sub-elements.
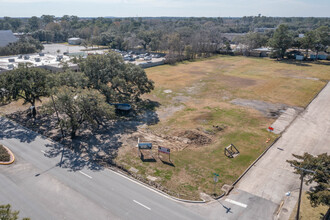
<box><xmin>0</xmin><ymin>0</ymin><xmax>330</xmax><ymax>17</ymax></box>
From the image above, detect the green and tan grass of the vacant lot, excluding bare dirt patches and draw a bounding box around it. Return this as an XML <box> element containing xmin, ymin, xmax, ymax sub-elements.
<box><xmin>117</xmin><ymin>56</ymin><xmax>330</xmax><ymax>199</ymax></box>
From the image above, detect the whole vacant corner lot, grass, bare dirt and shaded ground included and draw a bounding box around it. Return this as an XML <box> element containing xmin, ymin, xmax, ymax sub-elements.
<box><xmin>0</xmin><ymin>56</ymin><xmax>330</xmax><ymax>199</ymax></box>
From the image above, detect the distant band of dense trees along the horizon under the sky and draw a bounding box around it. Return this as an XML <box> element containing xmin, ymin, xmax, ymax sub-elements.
<box><xmin>0</xmin><ymin>15</ymin><xmax>330</xmax><ymax>54</ymax></box>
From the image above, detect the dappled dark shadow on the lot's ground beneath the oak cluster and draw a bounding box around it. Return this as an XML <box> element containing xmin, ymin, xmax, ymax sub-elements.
<box><xmin>4</xmin><ymin>100</ymin><xmax>159</xmax><ymax>171</ymax></box>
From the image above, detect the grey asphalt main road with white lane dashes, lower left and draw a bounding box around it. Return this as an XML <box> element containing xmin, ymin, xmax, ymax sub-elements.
<box><xmin>0</xmin><ymin>118</ymin><xmax>203</xmax><ymax>219</ymax></box>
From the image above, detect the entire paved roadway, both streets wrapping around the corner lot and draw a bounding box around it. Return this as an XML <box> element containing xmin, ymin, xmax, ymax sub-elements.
<box><xmin>0</xmin><ymin>81</ymin><xmax>330</xmax><ymax>220</ymax></box>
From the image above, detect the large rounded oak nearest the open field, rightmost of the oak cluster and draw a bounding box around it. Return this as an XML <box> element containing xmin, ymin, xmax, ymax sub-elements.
<box><xmin>79</xmin><ymin>52</ymin><xmax>154</xmax><ymax>102</ymax></box>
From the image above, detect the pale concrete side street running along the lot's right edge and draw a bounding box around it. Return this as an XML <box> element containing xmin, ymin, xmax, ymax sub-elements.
<box><xmin>236</xmin><ymin>83</ymin><xmax>330</xmax><ymax>219</ymax></box>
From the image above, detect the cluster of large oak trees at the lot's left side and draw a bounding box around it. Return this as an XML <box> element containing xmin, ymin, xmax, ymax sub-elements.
<box><xmin>0</xmin><ymin>52</ymin><xmax>154</xmax><ymax>138</ymax></box>
